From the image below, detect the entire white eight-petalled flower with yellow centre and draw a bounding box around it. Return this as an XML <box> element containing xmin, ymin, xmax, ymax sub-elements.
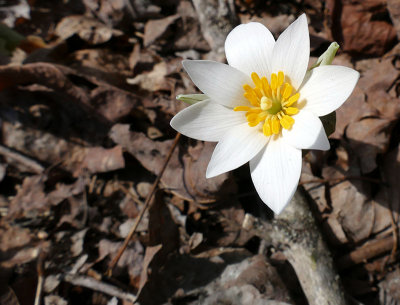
<box><xmin>171</xmin><ymin>14</ymin><xmax>359</xmax><ymax>214</ymax></box>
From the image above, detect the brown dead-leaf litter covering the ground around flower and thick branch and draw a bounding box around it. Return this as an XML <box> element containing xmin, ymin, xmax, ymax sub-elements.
<box><xmin>0</xmin><ymin>0</ymin><xmax>400</xmax><ymax>305</ymax></box>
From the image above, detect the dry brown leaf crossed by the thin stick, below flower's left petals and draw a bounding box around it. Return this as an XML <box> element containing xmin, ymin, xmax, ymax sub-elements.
<box><xmin>110</xmin><ymin>124</ymin><xmax>235</xmax><ymax>202</ymax></box>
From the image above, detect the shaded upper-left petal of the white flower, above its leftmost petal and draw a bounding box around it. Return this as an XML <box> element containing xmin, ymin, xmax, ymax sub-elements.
<box><xmin>182</xmin><ymin>60</ymin><xmax>252</xmax><ymax>108</ymax></box>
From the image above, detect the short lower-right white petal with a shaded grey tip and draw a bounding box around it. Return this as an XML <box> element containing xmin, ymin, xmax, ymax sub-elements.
<box><xmin>282</xmin><ymin>110</ymin><xmax>329</xmax><ymax>150</ymax></box>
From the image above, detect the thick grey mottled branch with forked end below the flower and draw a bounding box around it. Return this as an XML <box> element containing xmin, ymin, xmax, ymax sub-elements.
<box><xmin>243</xmin><ymin>188</ymin><xmax>346</xmax><ymax>305</ymax></box>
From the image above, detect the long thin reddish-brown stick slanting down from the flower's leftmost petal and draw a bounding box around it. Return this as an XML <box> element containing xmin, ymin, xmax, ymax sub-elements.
<box><xmin>107</xmin><ymin>132</ymin><xmax>181</xmax><ymax>276</ymax></box>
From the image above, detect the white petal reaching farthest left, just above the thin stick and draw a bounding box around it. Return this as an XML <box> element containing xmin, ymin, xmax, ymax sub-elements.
<box><xmin>171</xmin><ymin>100</ymin><xmax>246</xmax><ymax>141</ymax></box>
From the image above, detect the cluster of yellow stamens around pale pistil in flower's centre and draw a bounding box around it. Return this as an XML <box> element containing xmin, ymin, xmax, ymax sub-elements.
<box><xmin>233</xmin><ymin>71</ymin><xmax>300</xmax><ymax>137</ymax></box>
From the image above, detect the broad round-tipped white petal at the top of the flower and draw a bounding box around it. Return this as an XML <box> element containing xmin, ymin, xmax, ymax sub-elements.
<box><xmin>225</xmin><ymin>22</ymin><xmax>275</xmax><ymax>77</ymax></box>
